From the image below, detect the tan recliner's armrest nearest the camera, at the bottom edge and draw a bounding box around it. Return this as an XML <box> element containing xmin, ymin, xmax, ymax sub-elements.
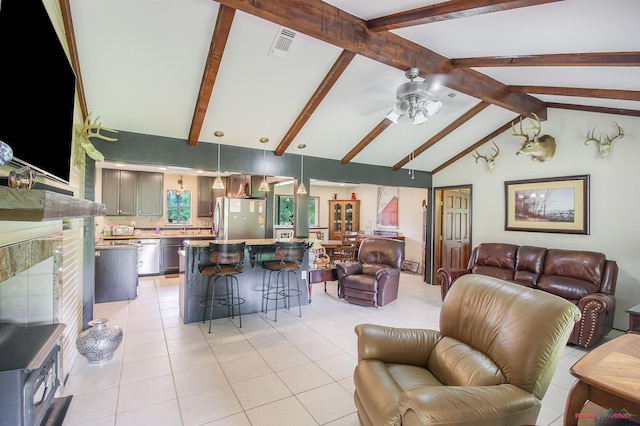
<box><xmin>399</xmin><ymin>384</ymin><xmax>540</xmax><ymax>425</ymax></box>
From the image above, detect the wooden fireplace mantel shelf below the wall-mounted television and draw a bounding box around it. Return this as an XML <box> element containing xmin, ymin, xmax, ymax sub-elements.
<box><xmin>0</xmin><ymin>187</ymin><xmax>107</xmax><ymax>222</ymax></box>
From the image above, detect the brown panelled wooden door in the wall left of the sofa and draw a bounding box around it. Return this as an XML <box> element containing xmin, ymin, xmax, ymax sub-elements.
<box><xmin>441</xmin><ymin>190</ymin><xmax>470</xmax><ymax>268</ymax></box>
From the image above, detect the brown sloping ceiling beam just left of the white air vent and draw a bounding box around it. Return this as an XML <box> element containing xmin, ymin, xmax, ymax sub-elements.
<box><xmin>188</xmin><ymin>5</ymin><xmax>236</xmax><ymax>146</ymax></box>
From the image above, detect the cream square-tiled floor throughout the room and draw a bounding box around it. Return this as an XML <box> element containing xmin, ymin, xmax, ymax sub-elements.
<box><xmin>58</xmin><ymin>273</ymin><xmax>622</xmax><ymax>426</ymax></box>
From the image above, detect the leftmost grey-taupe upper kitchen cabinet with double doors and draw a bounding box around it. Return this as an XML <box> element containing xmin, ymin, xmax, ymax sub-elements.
<box><xmin>102</xmin><ymin>169</ymin><xmax>138</xmax><ymax>216</ymax></box>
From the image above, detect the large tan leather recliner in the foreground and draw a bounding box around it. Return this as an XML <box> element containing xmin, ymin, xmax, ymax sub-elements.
<box><xmin>353</xmin><ymin>274</ymin><xmax>580</xmax><ymax>426</ymax></box>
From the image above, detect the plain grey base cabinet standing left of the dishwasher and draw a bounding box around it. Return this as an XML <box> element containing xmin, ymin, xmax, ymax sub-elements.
<box><xmin>94</xmin><ymin>245</ymin><xmax>138</xmax><ymax>303</ymax></box>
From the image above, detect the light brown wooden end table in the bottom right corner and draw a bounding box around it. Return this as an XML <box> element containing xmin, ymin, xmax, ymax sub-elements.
<box><xmin>564</xmin><ymin>333</ymin><xmax>640</xmax><ymax>426</ymax></box>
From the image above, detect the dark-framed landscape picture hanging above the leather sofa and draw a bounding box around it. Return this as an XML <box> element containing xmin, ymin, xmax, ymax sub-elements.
<box><xmin>504</xmin><ymin>175</ymin><xmax>589</xmax><ymax>235</ymax></box>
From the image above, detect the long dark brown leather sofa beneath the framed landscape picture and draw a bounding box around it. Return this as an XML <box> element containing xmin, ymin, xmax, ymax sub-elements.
<box><xmin>437</xmin><ymin>243</ymin><xmax>618</xmax><ymax>348</ymax></box>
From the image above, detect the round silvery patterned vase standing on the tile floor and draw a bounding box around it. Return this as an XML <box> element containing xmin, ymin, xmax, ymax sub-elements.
<box><xmin>76</xmin><ymin>318</ymin><xmax>122</xmax><ymax>364</ymax></box>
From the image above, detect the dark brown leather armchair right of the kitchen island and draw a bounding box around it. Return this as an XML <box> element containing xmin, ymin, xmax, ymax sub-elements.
<box><xmin>336</xmin><ymin>238</ymin><xmax>404</xmax><ymax>307</ymax></box>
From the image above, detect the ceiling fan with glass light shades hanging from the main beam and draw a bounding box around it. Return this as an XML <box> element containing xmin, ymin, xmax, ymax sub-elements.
<box><xmin>386</xmin><ymin>68</ymin><xmax>442</xmax><ymax>124</ymax></box>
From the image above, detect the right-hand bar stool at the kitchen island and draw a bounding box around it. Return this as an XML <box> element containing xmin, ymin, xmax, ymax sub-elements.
<box><xmin>262</xmin><ymin>241</ymin><xmax>307</xmax><ymax>321</ymax></box>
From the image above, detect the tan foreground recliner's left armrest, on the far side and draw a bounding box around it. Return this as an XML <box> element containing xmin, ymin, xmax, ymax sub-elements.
<box><xmin>355</xmin><ymin>324</ymin><xmax>442</xmax><ymax>366</ymax></box>
